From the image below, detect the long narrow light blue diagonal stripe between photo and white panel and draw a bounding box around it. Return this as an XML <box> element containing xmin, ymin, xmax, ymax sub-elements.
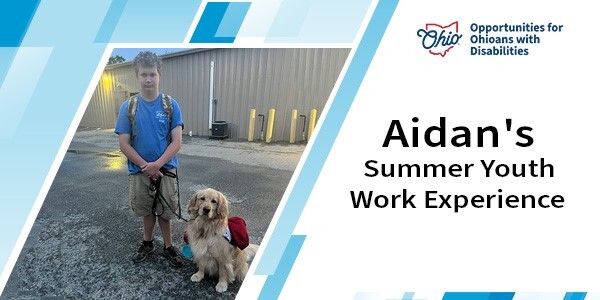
<box><xmin>256</xmin><ymin>0</ymin><xmax>398</xmax><ymax>275</ymax></box>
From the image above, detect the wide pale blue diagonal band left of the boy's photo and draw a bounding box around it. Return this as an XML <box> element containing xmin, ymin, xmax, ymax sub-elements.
<box><xmin>0</xmin><ymin>0</ymin><xmax>110</xmax><ymax>278</ymax></box>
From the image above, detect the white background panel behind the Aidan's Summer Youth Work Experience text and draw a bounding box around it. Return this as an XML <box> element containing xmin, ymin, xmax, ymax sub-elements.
<box><xmin>274</xmin><ymin>1</ymin><xmax>600</xmax><ymax>299</ymax></box>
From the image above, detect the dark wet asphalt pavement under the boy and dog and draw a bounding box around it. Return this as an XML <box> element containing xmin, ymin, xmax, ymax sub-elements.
<box><xmin>0</xmin><ymin>128</ymin><xmax>305</xmax><ymax>300</ymax></box>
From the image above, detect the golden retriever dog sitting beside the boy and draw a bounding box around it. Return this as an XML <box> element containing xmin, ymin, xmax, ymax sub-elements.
<box><xmin>187</xmin><ymin>188</ymin><xmax>258</xmax><ymax>293</ymax></box>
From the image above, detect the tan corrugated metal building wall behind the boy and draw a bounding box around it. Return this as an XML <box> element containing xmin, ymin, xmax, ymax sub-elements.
<box><xmin>80</xmin><ymin>49</ymin><xmax>350</xmax><ymax>141</ymax></box>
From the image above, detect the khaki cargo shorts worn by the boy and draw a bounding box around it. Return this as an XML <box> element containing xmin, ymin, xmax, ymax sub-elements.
<box><xmin>129</xmin><ymin>169</ymin><xmax>179</xmax><ymax>220</ymax></box>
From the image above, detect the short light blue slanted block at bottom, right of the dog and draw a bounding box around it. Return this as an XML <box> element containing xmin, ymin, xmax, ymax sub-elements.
<box><xmin>258</xmin><ymin>235</ymin><xmax>306</xmax><ymax>300</ymax></box>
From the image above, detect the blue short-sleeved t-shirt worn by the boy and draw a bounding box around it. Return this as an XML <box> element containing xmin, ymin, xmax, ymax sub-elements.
<box><xmin>115</xmin><ymin>93</ymin><xmax>183</xmax><ymax>174</ymax></box>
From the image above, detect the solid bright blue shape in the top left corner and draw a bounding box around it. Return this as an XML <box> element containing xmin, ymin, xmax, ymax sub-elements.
<box><xmin>0</xmin><ymin>0</ymin><xmax>40</xmax><ymax>47</ymax></box>
